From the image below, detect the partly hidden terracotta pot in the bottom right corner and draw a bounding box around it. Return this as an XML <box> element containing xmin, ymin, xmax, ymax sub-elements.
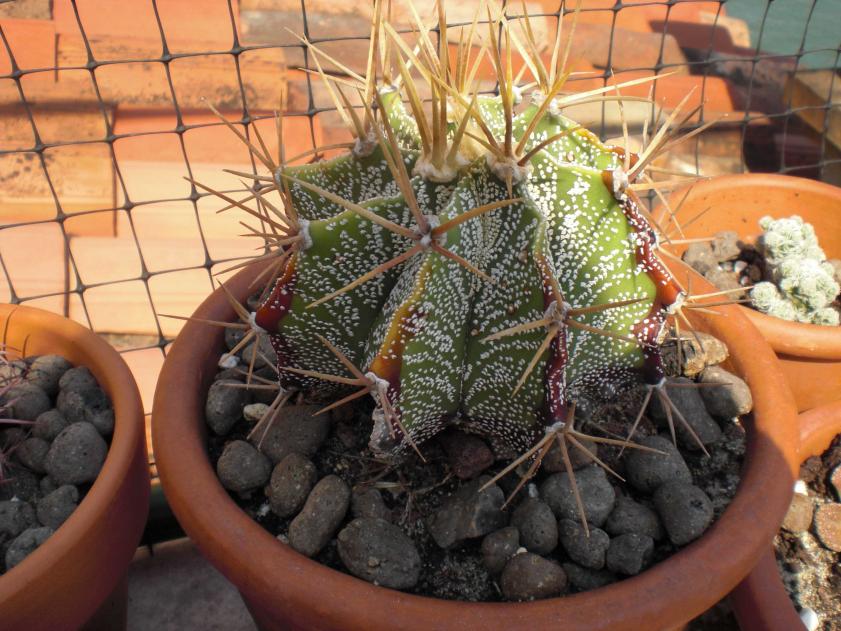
<box><xmin>730</xmin><ymin>401</ymin><xmax>841</xmax><ymax>631</ymax></box>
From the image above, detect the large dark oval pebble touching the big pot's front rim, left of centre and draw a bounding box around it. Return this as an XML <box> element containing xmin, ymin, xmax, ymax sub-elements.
<box><xmin>338</xmin><ymin>517</ymin><xmax>421</xmax><ymax>589</ymax></box>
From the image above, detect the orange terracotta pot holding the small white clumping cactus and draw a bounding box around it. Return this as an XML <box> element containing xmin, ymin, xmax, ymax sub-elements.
<box><xmin>658</xmin><ymin>173</ymin><xmax>841</xmax><ymax>412</ymax></box>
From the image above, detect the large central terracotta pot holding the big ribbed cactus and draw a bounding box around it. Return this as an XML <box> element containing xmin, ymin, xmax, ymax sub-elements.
<box><xmin>152</xmin><ymin>266</ymin><xmax>797</xmax><ymax>631</ymax></box>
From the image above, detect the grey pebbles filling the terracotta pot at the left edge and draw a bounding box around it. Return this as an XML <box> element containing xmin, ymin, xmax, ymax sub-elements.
<box><xmin>0</xmin><ymin>355</ymin><xmax>114</xmax><ymax>575</ymax></box>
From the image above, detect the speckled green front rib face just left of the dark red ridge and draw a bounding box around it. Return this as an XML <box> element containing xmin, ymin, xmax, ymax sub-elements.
<box><xmin>462</xmin><ymin>178</ymin><xmax>548</xmax><ymax>452</ymax></box>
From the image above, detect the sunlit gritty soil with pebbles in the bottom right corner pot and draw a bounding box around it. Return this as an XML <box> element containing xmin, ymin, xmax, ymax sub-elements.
<box><xmin>774</xmin><ymin>435</ymin><xmax>841</xmax><ymax>631</ymax></box>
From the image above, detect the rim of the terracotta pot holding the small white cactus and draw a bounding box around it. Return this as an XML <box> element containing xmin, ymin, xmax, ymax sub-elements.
<box><xmin>655</xmin><ymin>173</ymin><xmax>841</xmax><ymax>360</ymax></box>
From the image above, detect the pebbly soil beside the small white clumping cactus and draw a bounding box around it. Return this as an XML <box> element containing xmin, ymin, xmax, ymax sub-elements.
<box><xmin>683</xmin><ymin>231</ymin><xmax>841</xmax><ymax>324</ymax></box>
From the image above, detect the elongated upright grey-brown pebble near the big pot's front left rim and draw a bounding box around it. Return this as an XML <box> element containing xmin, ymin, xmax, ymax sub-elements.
<box><xmin>289</xmin><ymin>475</ymin><xmax>351</xmax><ymax>557</ymax></box>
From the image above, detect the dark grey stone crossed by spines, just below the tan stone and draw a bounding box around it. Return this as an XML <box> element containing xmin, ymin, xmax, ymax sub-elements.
<box><xmin>649</xmin><ymin>377</ymin><xmax>722</xmax><ymax>451</ymax></box>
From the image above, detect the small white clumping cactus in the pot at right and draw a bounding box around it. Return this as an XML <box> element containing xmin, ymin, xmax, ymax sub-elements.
<box><xmin>751</xmin><ymin>215</ymin><xmax>841</xmax><ymax>325</ymax></box>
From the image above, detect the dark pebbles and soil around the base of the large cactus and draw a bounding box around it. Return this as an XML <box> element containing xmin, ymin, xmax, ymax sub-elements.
<box><xmin>205</xmin><ymin>312</ymin><xmax>752</xmax><ymax>608</ymax></box>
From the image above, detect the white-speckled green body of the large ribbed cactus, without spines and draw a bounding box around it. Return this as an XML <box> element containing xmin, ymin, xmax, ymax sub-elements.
<box><xmin>251</xmin><ymin>85</ymin><xmax>680</xmax><ymax>454</ymax></box>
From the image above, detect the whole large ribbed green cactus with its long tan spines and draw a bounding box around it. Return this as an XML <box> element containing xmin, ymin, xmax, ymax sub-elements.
<box><xmin>236</xmin><ymin>5</ymin><xmax>685</xmax><ymax>456</ymax></box>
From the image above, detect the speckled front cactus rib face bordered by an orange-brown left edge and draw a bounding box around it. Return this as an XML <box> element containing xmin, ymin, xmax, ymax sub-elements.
<box><xmin>368</xmin><ymin>174</ymin><xmax>482</xmax><ymax>451</ymax></box>
